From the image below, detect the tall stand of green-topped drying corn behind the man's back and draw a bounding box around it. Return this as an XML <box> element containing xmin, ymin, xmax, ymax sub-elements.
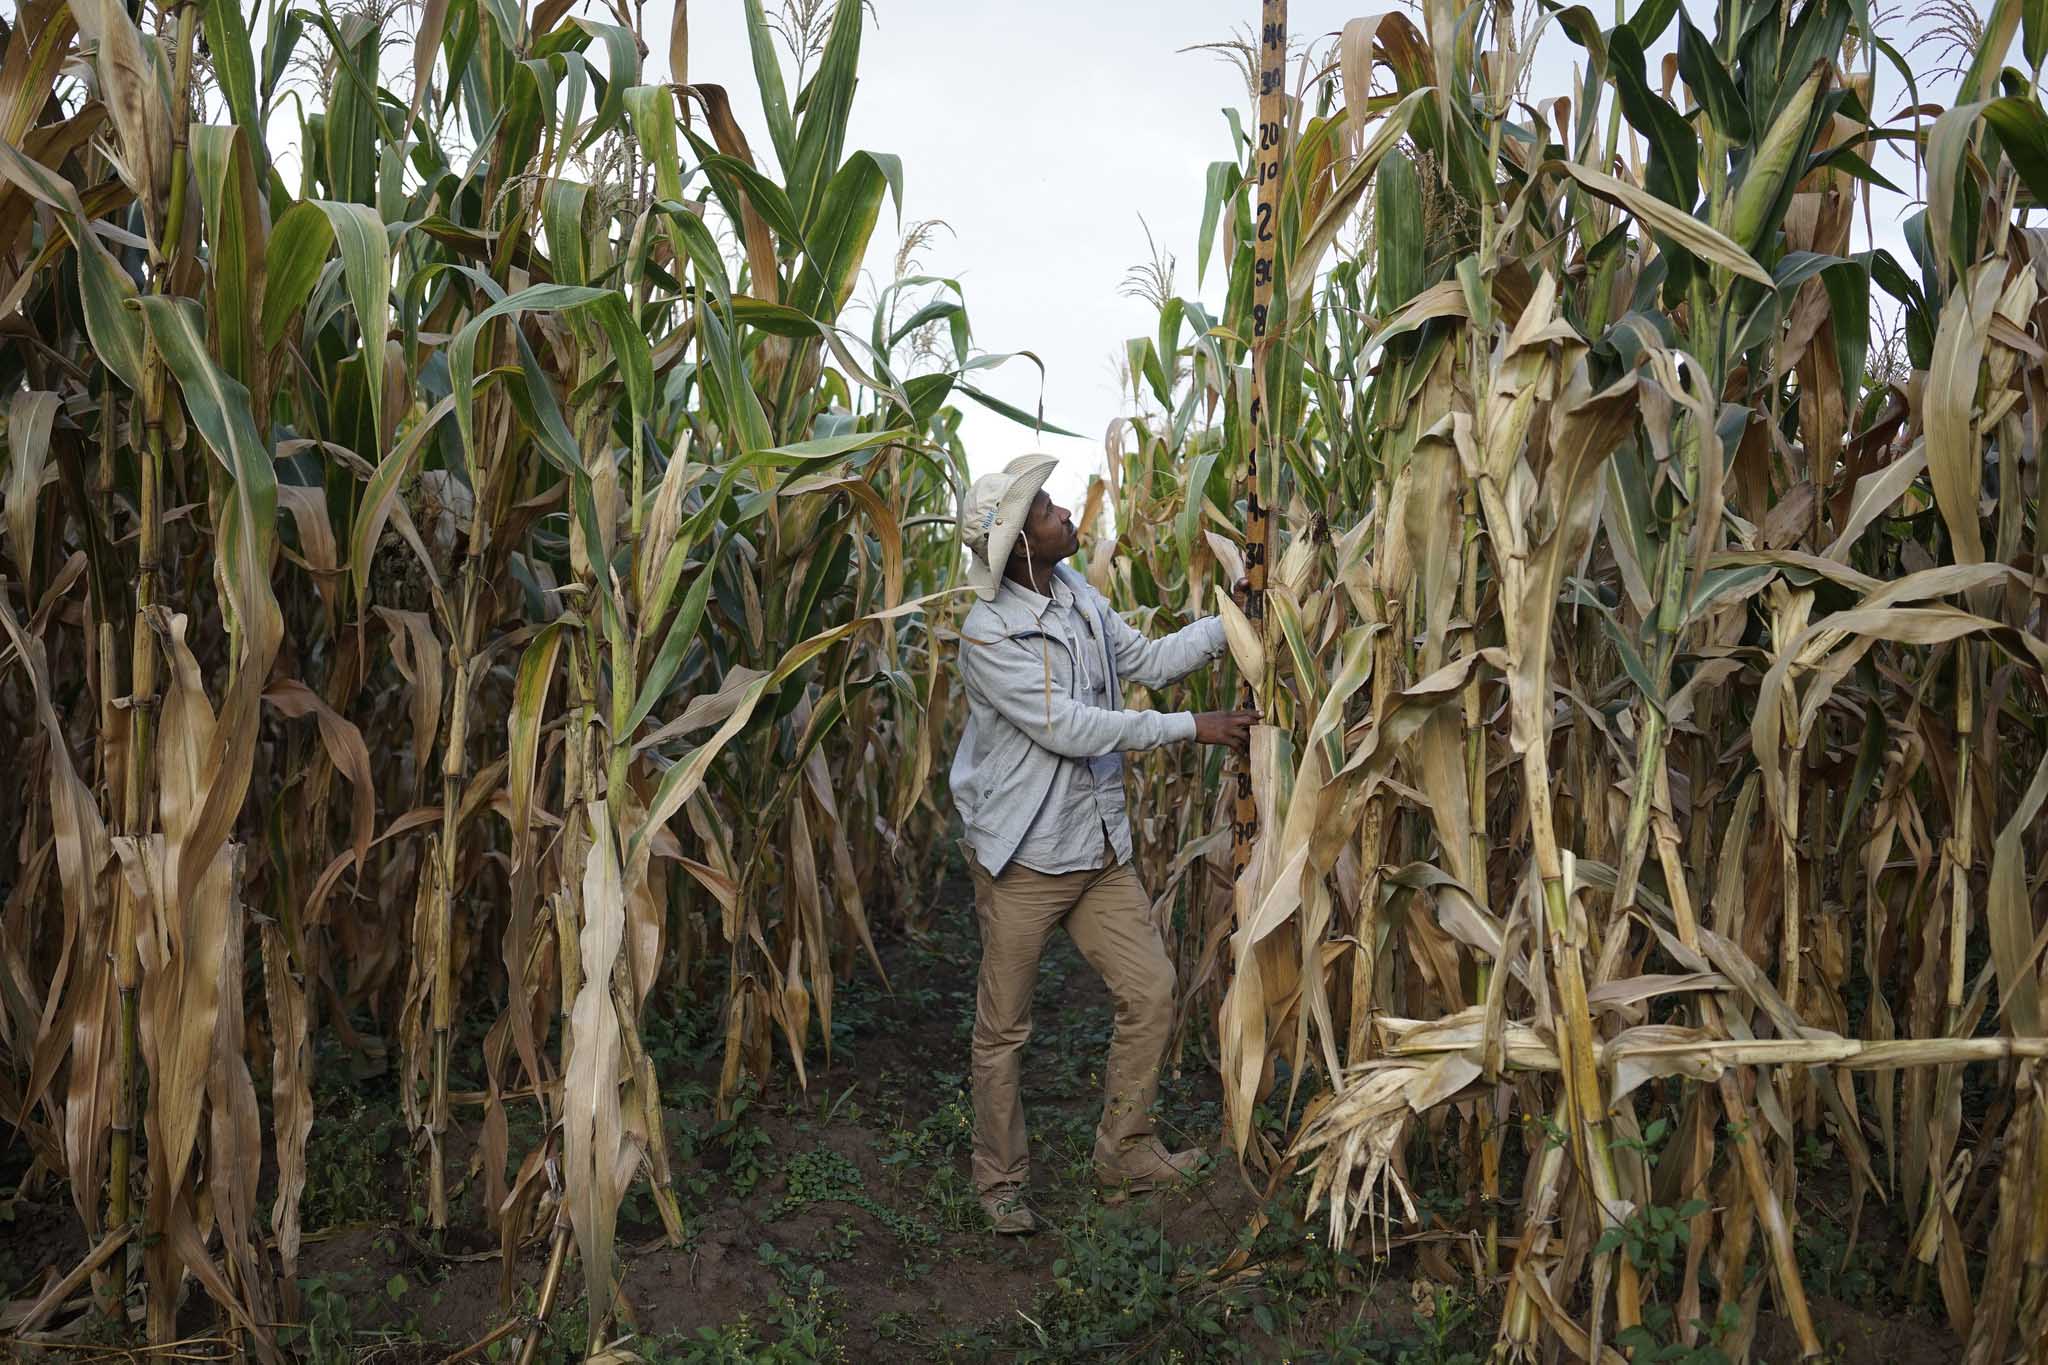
<box><xmin>0</xmin><ymin>0</ymin><xmax>1022</xmax><ymax>1359</ymax></box>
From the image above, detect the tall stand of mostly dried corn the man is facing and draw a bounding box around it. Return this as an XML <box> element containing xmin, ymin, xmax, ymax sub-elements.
<box><xmin>1102</xmin><ymin>2</ymin><xmax>2048</xmax><ymax>1361</ymax></box>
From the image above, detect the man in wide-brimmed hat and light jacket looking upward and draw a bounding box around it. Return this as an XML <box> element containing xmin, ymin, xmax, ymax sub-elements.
<box><xmin>952</xmin><ymin>454</ymin><xmax>1255</xmax><ymax>1234</ymax></box>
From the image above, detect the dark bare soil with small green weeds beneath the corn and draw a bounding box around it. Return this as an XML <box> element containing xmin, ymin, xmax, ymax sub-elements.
<box><xmin>0</xmin><ymin>884</ymin><xmax>1958</xmax><ymax>1365</ymax></box>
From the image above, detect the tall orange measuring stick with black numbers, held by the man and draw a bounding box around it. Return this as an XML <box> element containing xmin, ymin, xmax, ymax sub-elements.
<box><xmin>1231</xmin><ymin>0</ymin><xmax>1286</xmax><ymax>876</ymax></box>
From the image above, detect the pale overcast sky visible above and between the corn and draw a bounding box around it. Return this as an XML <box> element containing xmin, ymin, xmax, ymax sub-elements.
<box><xmin>647</xmin><ymin>0</ymin><xmax>1982</xmax><ymax>511</ymax></box>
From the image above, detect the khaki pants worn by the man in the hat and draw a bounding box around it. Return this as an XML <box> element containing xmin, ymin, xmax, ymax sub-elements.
<box><xmin>969</xmin><ymin>853</ymin><xmax>1174</xmax><ymax>1191</ymax></box>
